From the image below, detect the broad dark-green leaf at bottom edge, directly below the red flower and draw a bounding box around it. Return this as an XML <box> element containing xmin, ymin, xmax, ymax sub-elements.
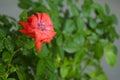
<box><xmin>35</xmin><ymin>56</ymin><xmax>56</xmax><ymax>80</ymax></box>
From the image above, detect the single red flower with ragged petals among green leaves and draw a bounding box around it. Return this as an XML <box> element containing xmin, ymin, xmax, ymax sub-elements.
<box><xmin>19</xmin><ymin>12</ymin><xmax>56</xmax><ymax>51</ymax></box>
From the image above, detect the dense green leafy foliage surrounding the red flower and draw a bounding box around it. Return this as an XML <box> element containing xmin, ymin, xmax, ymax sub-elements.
<box><xmin>0</xmin><ymin>0</ymin><xmax>119</xmax><ymax>80</ymax></box>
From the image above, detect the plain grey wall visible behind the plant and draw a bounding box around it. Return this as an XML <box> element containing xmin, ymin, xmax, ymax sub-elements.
<box><xmin>0</xmin><ymin>0</ymin><xmax>120</xmax><ymax>80</ymax></box>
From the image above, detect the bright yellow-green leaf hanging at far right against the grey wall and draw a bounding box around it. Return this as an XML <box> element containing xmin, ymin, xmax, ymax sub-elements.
<box><xmin>104</xmin><ymin>43</ymin><xmax>117</xmax><ymax>66</ymax></box>
